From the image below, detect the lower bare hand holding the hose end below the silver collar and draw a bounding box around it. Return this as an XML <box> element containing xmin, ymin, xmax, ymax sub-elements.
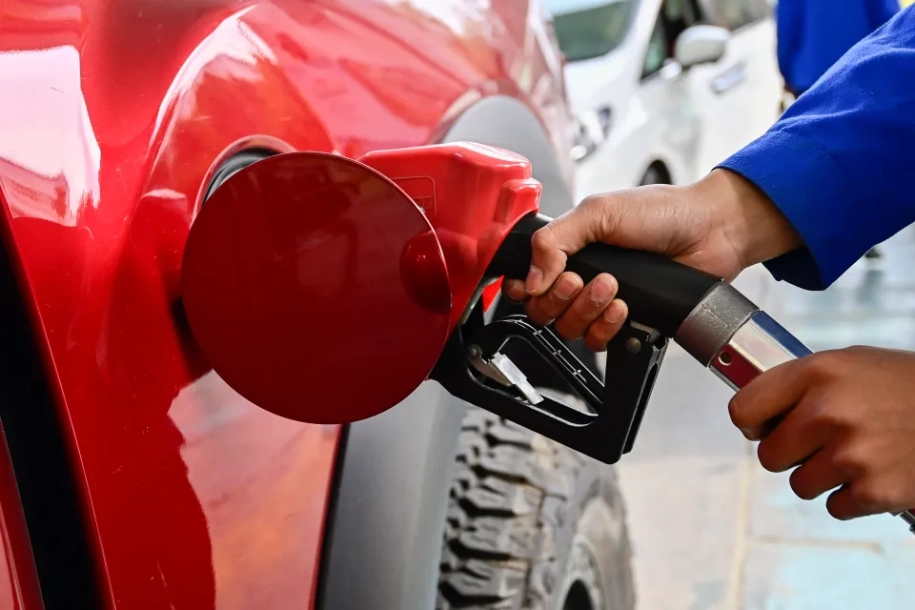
<box><xmin>730</xmin><ymin>347</ymin><xmax>915</xmax><ymax>520</ymax></box>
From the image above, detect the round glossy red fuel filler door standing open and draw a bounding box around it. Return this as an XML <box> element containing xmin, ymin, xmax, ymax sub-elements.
<box><xmin>182</xmin><ymin>152</ymin><xmax>451</xmax><ymax>424</ymax></box>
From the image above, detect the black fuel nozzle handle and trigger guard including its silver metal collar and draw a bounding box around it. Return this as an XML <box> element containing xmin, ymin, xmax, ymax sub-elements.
<box><xmin>430</xmin><ymin>214</ymin><xmax>915</xmax><ymax>533</ymax></box>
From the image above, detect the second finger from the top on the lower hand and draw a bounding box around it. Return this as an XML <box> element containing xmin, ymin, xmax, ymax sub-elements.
<box><xmin>757</xmin><ymin>392</ymin><xmax>828</xmax><ymax>472</ymax></box>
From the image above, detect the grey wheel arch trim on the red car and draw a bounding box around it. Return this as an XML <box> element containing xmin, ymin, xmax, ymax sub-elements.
<box><xmin>315</xmin><ymin>96</ymin><xmax>574</xmax><ymax>610</ymax></box>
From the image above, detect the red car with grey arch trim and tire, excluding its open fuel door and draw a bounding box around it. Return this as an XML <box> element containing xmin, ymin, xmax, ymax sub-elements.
<box><xmin>0</xmin><ymin>0</ymin><xmax>634</xmax><ymax>610</ymax></box>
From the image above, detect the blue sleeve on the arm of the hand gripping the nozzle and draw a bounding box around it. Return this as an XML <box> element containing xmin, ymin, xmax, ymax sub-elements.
<box><xmin>719</xmin><ymin>8</ymin><xmax>915</xmax><ymax>290</ymax></box>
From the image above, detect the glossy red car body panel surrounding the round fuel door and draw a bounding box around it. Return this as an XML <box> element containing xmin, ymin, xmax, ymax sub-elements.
<box><xmin>0</xmin><ymin>0</ymin><xmax>571</xmax><ymax>609</ymax></box>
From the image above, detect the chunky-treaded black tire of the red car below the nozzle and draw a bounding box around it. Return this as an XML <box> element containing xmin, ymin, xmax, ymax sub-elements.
<box><xmin>436</xmin><ymin>407</ymin><xmax>635</xmax><ymax>610</ymax></box>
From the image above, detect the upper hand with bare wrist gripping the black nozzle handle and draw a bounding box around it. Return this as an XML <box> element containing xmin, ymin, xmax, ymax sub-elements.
<box><xmin>502</xmin><ymin>170</ymin><xmax>800</xmax><ymax>351</ymax></box>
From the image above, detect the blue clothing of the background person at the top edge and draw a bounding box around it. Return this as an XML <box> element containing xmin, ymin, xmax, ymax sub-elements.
<box><xmin>775</xmin><ymin>0</ymin><xmax>899</xmax><ymax>94</ymax></box>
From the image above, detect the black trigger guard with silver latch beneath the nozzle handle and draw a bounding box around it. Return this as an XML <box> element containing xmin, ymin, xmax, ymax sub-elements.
<box><xmin>430</xmin><ymin>306</ymin><xmax>667</xmax><ymax>463</ymax></box>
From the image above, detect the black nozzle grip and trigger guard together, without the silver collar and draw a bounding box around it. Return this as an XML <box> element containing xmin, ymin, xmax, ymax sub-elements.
<box><xmin>430</xmin><ymin>213</ymin><xmax>720</xmax><ymax>463</ymax></box>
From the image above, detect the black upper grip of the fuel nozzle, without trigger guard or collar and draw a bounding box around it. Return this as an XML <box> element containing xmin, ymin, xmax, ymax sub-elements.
<box><xmin>489</xmin><ymin>214</ymin><xmax>722</xmax><ymax>337</ymax></box>
